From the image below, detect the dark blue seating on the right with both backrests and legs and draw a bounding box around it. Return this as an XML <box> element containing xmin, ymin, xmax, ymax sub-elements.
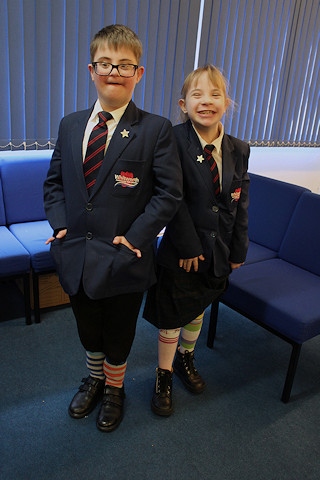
<box><xmin>207</xmin><ymin>174</ymin><xmax>320</xmax><ymax>403</ymax></box>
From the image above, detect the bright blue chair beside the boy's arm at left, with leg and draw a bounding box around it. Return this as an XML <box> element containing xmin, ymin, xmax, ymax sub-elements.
<box><xmin>0</xmin><ymin>150</ymin><xmax>55</xmax><ymax>323</ymax></box>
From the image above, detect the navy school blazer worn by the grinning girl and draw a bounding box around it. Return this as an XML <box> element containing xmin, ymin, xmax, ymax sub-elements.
<box><xmin>158</xmin><ymin>120</ymin><xmax>250</xmax><ymax>277</ymax></box>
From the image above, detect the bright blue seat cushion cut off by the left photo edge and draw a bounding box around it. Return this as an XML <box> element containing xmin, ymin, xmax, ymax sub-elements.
<box><xmin>0</xmin><ymin>226</ymin><xmax>30</xmax><ymax>277</ymax></box>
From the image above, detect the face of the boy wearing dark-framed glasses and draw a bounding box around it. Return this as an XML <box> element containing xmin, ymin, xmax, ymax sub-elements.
<box><xmin>88</xmin><ymin>43</ymin><xmax>144</xmax><ymax>112</ymax></box>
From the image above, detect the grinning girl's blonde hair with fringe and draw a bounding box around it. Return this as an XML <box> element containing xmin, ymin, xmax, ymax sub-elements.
<box><xmin>181</xmin><ymin>63</ymin><xmax>235</xmax><ymax>121</ymax></box>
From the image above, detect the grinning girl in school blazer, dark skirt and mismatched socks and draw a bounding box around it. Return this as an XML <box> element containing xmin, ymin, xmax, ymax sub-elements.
<box><xmin>144</xmin><ymin>65</ymin><xmax>250</xmax><ymax>416</ymax></box>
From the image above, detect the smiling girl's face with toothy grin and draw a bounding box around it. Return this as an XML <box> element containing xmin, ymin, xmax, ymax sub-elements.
<box><xmin>179</xmin><ymin>72</ymin><xmax>229</xmax><ymax>140</ymax></box>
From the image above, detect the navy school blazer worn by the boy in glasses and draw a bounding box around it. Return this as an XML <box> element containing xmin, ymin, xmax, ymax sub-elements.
<box><xmin>44</xmin><ymin>101</ymin><xmax>182</xmax><ymax>299</ymax></box>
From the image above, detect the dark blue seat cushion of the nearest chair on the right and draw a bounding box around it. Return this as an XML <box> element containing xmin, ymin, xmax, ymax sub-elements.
<box><xmin>223</xmin><ymin>259</ymin><xmax>320</xmax><ymax>343</ymax></box>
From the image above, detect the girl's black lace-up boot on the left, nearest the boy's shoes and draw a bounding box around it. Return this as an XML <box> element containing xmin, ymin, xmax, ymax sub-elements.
<box><xmin>151</xmin><ymin>367</ymin><xmax>173</xmax><ymax>417</ymax></box>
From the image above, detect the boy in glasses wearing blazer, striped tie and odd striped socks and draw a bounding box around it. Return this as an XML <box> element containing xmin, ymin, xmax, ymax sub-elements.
<box><xmin>44</xmin><ymin>25</ymin><xmax>182</xmax><ymax>432</ymax></box>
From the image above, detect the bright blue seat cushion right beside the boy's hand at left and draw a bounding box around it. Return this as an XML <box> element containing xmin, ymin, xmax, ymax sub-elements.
<box><xmin>9</xmin><ymin>220</ymin><xmax>55</xmax><ymax>273</ymax></box>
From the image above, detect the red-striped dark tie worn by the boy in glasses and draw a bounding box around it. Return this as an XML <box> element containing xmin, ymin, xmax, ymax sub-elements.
<box><xmin>83</xmin><ymin>112</ymin><xmax>112</xmax><ymax>194</ymax></box>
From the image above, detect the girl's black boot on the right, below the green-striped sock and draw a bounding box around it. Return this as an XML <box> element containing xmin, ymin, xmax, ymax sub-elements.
<box><xmin>173</xmin><ymin>350</ymin><xmax>206</xmax><ymax>393</ymax></box>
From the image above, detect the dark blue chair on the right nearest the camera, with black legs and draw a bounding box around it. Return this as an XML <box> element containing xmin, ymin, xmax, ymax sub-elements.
<box><xmin>207</xmin><ymin>183</ymin><xmax>320</xmax><ymax>403</ymax></box>
